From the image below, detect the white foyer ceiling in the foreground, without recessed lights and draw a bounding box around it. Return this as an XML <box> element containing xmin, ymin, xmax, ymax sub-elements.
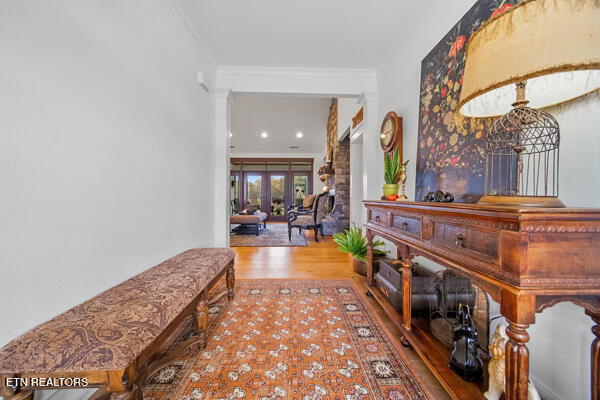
<box><xmin>180</xmin><ymin>0</ymin><xmax>421</xmax><ymax>68</ymax></box>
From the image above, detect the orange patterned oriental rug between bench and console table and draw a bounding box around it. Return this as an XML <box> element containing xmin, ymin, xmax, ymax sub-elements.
<box><xmin>144</xmin><ymin>280</ymin><xmax>432</xmax><ymax>400</ymax></box>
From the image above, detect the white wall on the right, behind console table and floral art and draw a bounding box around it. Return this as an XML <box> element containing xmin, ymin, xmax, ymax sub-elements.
<box><xmin>376</xmin><ymin>0</ymin><xmax>600</xmax><ymax>400</ymax></box>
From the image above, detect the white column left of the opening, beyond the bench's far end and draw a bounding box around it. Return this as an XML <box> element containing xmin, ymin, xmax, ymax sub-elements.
<box><xmin>214</xmin><ymin>89</ymin><xmax>231</xmax><ymax>247</ymax></box>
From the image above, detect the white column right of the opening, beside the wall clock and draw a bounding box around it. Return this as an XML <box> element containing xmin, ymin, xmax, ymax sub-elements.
<box><xmin>360</xmin><ymin>92</ymin><xmax>384</xmax><ymax>209</ymax></box>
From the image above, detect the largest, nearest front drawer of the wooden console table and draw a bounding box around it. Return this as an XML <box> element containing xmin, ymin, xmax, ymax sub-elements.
<box><xmin>433</xmin><ymin>222</ymin><xmax>499</xmax><ymax>261</ymax></box>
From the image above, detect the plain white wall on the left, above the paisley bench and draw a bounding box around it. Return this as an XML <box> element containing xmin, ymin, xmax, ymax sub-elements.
<box><xmin>0</xmin><ymin>0</ymin><xmax>216</xmax><ymax>374</ymax></box>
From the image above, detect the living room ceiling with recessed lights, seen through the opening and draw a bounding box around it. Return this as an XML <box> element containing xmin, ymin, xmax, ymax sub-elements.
<box><xmin>231</xmin><ymin>93</ymin><xmax>331</xmax><ymax>156</ymax></box>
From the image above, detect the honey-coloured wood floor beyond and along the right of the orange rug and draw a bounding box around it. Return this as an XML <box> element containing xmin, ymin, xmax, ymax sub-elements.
<box><xmin>232</xmin><ymin>225</ymin><xmax>450</xmax><ymax>400</ymax></box>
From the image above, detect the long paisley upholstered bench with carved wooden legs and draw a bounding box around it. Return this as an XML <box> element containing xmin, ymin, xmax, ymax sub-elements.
<box><xmin>0</xmin><ymin>248</ymin><xmax>235</xmax><ymax>400</ymax></box>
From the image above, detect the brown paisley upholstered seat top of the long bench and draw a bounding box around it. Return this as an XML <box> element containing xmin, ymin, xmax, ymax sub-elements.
<box><xmin>0</xmin><ymin>248</ymin><xmax>234</xmax><ymax>373</ymax></box>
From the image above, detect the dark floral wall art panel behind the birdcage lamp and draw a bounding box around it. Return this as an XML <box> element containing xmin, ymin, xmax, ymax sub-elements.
<box><xmin>415</xmin><ymin>0</ymin><xmax>520</xmax><ymax>203</ymax></box>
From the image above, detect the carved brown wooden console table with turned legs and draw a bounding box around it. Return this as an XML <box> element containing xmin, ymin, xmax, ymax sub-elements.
<box><xmin>364</xmin><ymin>201</ymin><xmax>600</xmax><ymax>400</ymax></box>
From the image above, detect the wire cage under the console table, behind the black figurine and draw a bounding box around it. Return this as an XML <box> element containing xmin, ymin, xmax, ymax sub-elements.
<box><xmin>429</xmin><ymin>270</ymin><xmax>490</xmax><ymax>358</ymax></box>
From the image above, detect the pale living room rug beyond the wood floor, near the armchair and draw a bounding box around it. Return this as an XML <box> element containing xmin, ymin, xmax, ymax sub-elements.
<box><xmin>230</xmin><ymin>223</ymin><xmax>308</xmax><ymax>247</ymax></box>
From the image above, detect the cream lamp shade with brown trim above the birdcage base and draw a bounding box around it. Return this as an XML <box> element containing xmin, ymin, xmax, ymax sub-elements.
<box><xmin>458</xmin><ymin>0</ymin><xmax>600</xmax><ymax>117</ymax></box>
